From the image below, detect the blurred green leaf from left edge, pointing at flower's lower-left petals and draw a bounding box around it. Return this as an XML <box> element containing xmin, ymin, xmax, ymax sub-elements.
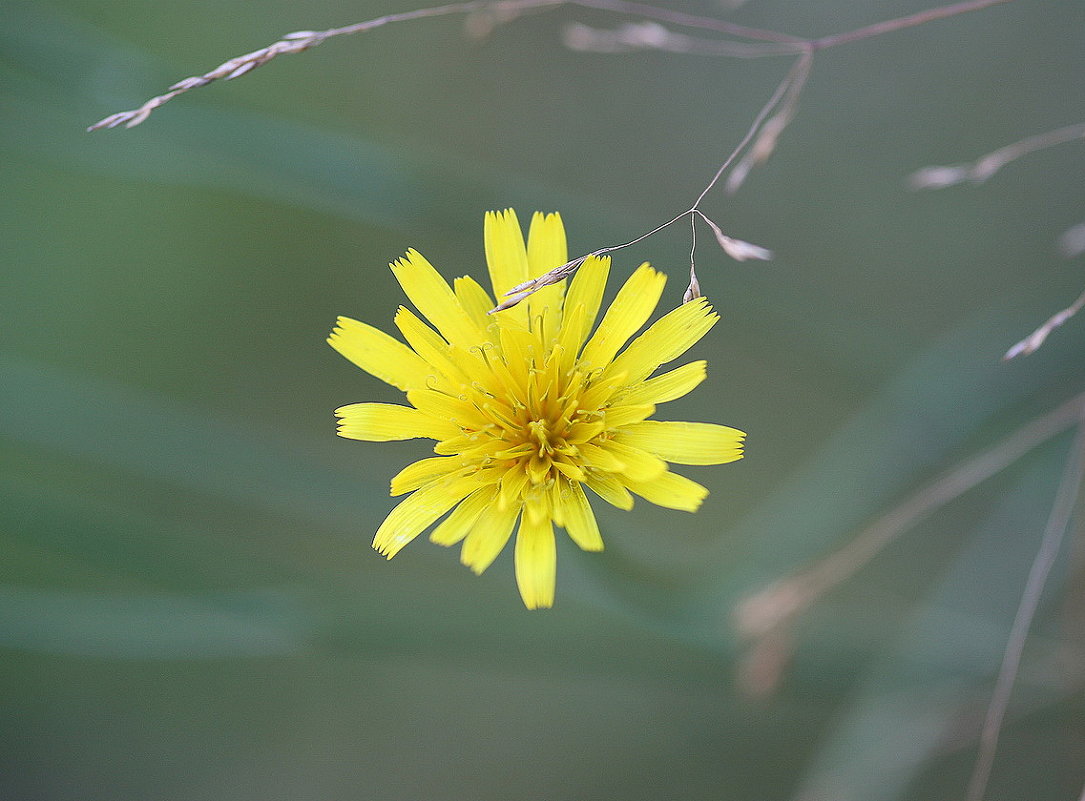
<box><xmin>0</xmin><ymin>356</ymin><xmax>383</xmax><ymax>525</ymax></box>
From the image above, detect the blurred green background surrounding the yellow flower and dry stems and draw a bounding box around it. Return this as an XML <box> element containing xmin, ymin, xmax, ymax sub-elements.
<box><xmin>6</xmin><ymin>0</ymin><xmax>1085</xmax><ymax>801</ymax></box>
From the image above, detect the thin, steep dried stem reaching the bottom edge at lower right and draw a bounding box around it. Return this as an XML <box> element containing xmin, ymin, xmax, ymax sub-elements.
<box><xmin>966</xmin><ymin>425</ymin><xmax>1085</xmax><ymax>801</ymax></box>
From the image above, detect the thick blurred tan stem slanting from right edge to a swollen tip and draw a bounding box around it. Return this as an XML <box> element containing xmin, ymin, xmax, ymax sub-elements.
<box><xmin>735</xmin><ymin>393</ymin><xmax>1085</xmax><ymax>639</ymax></box>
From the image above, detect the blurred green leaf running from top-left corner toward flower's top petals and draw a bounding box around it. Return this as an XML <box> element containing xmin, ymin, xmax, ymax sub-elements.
<box><xmin>0</xmin><ymin>3</ymin><xmax>603</xmax><ymax>230</ymax></box>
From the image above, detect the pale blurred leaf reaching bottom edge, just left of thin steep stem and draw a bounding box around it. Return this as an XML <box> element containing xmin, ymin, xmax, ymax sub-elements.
<box><xmin>795</xmin><ymin>436</ymin><xmax>1069</xmax><ymax>801</ymax></box>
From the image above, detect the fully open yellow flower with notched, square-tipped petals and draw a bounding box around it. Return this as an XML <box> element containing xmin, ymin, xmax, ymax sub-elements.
<box><xmin>328</xmin><ymin>209</ymin><xmax>745</xmax><ymax>609</ymax></box>
